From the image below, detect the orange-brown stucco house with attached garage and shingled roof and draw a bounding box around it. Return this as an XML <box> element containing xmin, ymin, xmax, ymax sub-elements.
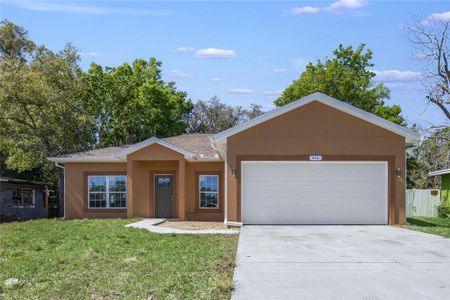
<box><xmin>49</xmin><ymin>93</ymin><xmax>421</xmax><ymax>226</ymax></box>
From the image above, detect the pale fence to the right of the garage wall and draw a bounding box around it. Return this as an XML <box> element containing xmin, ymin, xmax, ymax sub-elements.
<box><xmin>406</xmin><ymin>189</ymin><xmax>441</xmax><ymax>217</ymax></box>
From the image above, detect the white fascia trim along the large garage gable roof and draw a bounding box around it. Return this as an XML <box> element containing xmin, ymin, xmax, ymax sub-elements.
<box><xmin>211</xmin><ymin>92</ymin><xmax>422</xmax><ymax>145</ymax></box>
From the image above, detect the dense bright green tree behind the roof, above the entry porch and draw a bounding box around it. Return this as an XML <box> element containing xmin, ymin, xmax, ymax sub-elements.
<box><xmin>82</xmin><ymin>58</ymin><xmax>193</xmax><ymax>147</ymax></box>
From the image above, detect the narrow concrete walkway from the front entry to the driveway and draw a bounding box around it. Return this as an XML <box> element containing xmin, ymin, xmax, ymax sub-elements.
<box><xmin>126</xmin><ymin>219</ymin><xmax>239</xmax><ymax>234</ymax></box>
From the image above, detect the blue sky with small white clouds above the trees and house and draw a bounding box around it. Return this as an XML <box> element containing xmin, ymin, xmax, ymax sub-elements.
<box><xmin>0</xmin><ymin>0</ymin><xmax>450</xmax><ymax>127</ymax></box>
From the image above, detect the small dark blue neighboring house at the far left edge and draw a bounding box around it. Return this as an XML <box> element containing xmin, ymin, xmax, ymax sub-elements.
<box><xmin>0</xmin><ymin>177</ymin><xmax>50</xmax><ymax>221</ymax></box>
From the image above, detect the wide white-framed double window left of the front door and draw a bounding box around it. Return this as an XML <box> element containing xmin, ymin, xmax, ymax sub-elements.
<box><xmin>88</xmin><ymin>175</ymin><xmax>127</xmax><ymax>208</ymax></box>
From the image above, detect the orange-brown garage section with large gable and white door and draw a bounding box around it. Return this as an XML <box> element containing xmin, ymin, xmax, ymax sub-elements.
<box><xmin>211</xmin><ymin>92</ymin><xmax>421</xmax><ymax>226</ymax></box>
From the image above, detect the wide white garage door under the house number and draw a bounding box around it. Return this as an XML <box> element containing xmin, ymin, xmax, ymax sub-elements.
<box><xmin>241</xmin><ymin>161</ymin><xmax>388</xmax><ymax>224</ymax></box>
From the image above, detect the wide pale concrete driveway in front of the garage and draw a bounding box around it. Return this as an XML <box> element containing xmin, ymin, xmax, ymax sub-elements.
<box><xmin>232</xmin><ymin>226</ymin><xmax>450</xmax><ymax>299</ymax></box>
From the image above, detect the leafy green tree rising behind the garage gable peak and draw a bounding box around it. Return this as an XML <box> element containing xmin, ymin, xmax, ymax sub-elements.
<box><xmin>275</xmin><ymin>44</ymin><xmax>405</xmax><ymax>125</ymax></box>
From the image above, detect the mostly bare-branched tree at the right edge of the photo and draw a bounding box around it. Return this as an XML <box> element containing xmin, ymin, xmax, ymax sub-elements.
<box><xmin>406</xmin><ymin>19</ymin><xmax>450</xmax><ymax>188</ymax></box>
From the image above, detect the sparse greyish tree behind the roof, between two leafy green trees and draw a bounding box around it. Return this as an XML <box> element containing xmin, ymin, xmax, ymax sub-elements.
<box><xmin>187</xmin><ymin>96</ymin><xmax>263</xmax><ymax>133</ymax></box>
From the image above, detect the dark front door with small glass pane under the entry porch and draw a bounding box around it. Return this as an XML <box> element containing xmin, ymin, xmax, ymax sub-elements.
<box><xmin>155</xmin><ymin>175</ymin><xmax>173</xmax><ymax>218</ymax></box>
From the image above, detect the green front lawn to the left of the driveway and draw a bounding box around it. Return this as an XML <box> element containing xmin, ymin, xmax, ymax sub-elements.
<box><xmin>0</xmin><ymin>219</ymin><xmax>238</xmax><ymax>299</ymax></box>
